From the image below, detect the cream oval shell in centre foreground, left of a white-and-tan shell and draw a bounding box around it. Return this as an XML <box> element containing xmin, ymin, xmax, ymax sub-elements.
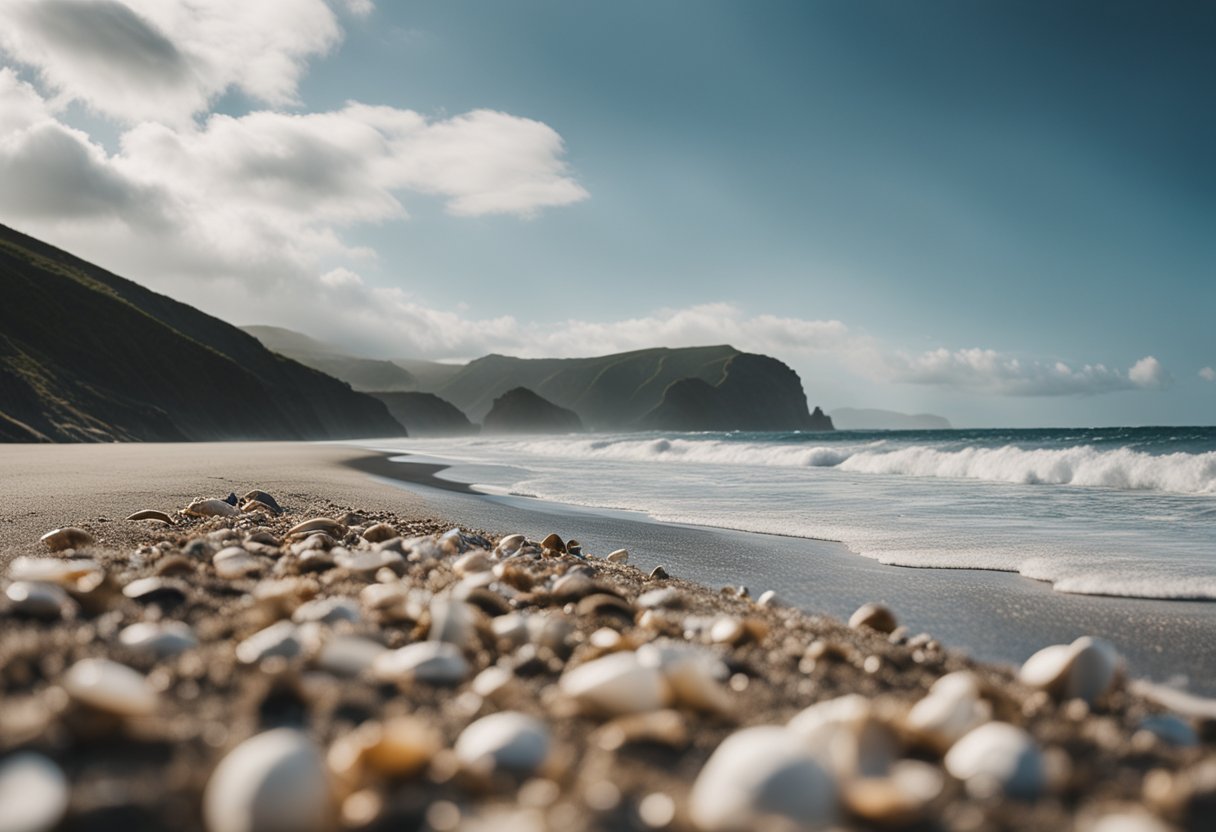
<box><xmin>558</xmin><ymin>652</ymin><xmax>671</xmax><ymax>714</ymax></box>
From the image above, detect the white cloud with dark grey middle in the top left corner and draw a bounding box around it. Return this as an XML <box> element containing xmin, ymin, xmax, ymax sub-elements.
<box><xmin>0</xmin><ymin>0</ymin><xmax>347</xmax><ymax>124</ymax></box>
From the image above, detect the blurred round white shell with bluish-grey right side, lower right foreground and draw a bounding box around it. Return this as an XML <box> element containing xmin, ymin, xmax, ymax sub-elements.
<box><xmin>945</xmin><ymin>723</ymin><xmax>1046</xmax><ymax>799</ymax></box>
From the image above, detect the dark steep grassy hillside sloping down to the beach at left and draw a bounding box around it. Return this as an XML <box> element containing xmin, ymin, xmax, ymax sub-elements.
<box><xmin>0</xmin><ymin>225</ymin><xmax>402</xmax><ymax>442</ymax></box>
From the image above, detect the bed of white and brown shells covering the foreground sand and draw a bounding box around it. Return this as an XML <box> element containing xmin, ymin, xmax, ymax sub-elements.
<box><xmin>0</xmin><ymin>489</ymin><xmax>1216</xmax><ymax>832</ymax></box>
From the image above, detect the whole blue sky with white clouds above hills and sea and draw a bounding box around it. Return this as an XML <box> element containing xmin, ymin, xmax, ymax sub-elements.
<box><xmin>0</xmin><ymin>0</ymin><xmax>1216</xmax><ymax>427</ymax></box>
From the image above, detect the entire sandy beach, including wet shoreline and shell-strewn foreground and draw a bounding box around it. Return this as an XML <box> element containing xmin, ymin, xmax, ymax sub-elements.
<box><xmin>0</xmin><ymin>443</ymin><xmax>1216</xmax><ymax>832</ymax></box>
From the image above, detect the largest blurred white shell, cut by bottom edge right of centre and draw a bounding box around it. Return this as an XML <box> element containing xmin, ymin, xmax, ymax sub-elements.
<box><xmin>688</xmin><ymin>726</ymin><xmax>839</xmax><ymax>832</ymax></box>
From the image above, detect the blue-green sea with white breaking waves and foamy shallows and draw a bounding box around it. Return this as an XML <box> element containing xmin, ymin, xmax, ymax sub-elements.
<box><xmin>369</xmin><ymin>428</ymin><xmax>1216</xmax><ymax>598</ymax></box>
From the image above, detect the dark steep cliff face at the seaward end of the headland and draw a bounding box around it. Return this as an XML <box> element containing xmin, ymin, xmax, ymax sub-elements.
<box><xmin>638</xmin><ymin>353</ymin><xmax>832</xmax><ymax>431</ymax></box>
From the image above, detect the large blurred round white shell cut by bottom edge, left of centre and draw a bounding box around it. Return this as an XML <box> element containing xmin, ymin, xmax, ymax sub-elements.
<box><xmin>203</xmin><ymin>727</ymin><xmax>336</xmax><ymax>832</ymax></box>
